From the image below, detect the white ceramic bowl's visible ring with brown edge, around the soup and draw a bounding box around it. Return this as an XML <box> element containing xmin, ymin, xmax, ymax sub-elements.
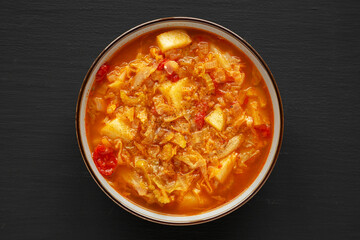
<box><xmin>75</xmin><ymin>17</ymin><xmax>284</xmax><ymax>225</ymax></box>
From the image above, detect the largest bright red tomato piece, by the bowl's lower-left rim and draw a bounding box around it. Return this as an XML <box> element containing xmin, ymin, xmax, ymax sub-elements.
<box><xmin>92</xmin><ymin>144</ymin><xmax>117</xmax><ymax>176</ymax></box>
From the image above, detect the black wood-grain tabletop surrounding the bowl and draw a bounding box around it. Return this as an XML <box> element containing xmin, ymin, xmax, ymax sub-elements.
<box><xmin>0</xmin><ymin>0</ymin><xmax>360</xmax><ymax>239</ymax></box>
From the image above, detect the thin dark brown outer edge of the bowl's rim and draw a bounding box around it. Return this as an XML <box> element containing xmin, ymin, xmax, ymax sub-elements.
<box><xmin>75</xmin><ymin>16</ymin><xmax>284</xmax><ymax>226</ymax></box>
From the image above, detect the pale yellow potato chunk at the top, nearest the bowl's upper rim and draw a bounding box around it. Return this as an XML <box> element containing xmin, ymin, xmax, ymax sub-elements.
<box><xmin>156</xmin><ymin>30</ymin><xmax>191</xmax><ymax>52</ymax></box>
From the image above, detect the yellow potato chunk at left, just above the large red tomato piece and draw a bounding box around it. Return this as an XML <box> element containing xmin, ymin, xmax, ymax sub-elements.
<box><xmin>101</xmin><ymin>118</ymin><xmax>136</xmax><ymax>141</ymax></box>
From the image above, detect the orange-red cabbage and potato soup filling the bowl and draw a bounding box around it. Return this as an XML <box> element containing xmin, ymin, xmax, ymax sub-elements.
<box><xmin>85</xmin><ymin>28</ymin><xmax>273</xmax><ymax>215</ymax></box>
